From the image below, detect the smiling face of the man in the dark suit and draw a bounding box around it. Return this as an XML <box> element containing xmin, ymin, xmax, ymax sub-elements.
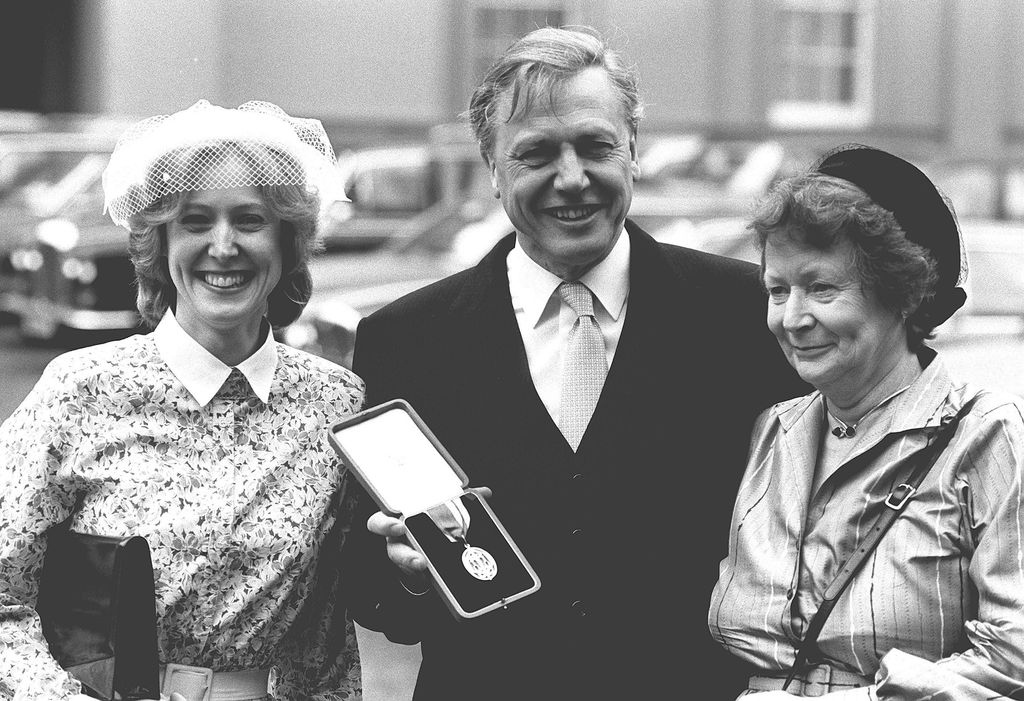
<box><xmin>483</xmin><ymin>67</ymin><xmax>640</xmax><ymax>282</ymax></box>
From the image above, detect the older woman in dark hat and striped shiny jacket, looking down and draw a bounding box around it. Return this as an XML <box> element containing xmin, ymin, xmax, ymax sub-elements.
<box><xmin>709</xmin><ymin>145</ymin><xmax>1024</xmax><ymax>699</ymax></box>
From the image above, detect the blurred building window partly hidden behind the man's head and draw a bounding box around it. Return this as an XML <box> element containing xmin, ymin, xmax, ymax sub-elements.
<box><xmin>469</xmin><ymin>0</ymin><xmax>565</xmax><ymax>80</ymax></box>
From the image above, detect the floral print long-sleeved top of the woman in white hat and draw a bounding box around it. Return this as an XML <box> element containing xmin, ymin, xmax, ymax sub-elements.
<box><xmin>0</xmin><ymin>317</ymin><xmax>364</xmax><ymax>701</ymax></box>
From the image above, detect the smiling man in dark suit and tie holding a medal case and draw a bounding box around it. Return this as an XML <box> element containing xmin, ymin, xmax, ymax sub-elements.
<box><xmin>345</xmin><ymin>28</ymin><xmax>804</xmax><ymax>699</ymax></box>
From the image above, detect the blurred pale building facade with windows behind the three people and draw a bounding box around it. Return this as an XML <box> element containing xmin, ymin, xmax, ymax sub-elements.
<box><xmin>7</xmin><ymin>0</ymin><xmax>1024</xmax><ymax>156</ymax></box>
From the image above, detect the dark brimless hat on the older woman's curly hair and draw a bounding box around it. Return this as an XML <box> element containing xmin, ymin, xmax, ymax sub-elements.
<box><xmin>814</xmin><ymin>143</ymin><xmax>967</xmax><ymax>327</ymax></box>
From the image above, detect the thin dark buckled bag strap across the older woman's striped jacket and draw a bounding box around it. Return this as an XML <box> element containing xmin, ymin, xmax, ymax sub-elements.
<box><xmin>782</xmin><ymin>396</ymin><xmax>978</xmax><ymax>691</ymax></box>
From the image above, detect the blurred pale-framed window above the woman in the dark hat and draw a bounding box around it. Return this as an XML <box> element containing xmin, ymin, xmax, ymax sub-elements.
<box><xmin>768</xmin><ymin>0</ymin><xmax>873</xmax><ymax>129</ymax></box>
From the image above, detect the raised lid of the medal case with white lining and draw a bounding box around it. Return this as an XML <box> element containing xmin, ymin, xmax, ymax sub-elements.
<box><xmin>329</xmin><ymin>399</ymin><xmax>469</xmax><ymax>516</ymax></box>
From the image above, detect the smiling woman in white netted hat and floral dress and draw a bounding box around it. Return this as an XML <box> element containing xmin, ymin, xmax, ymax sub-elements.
<box><xmin>0</xmin><ymin>100</ymin><xmax>364</xmax><ymax>701</ymax></box>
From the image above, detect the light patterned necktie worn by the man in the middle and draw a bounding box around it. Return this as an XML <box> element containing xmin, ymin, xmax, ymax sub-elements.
<box><xmin>558</xmin><ymin>282</ymin><xmax>608</xmax><ymax>450</ymax></box>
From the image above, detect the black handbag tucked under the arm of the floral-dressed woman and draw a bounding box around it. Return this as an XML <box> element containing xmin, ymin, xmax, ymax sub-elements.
<box><xmin>36</xmin><ymin>524</ymin><xmax>160</xmax><ymax>701</ymax></box>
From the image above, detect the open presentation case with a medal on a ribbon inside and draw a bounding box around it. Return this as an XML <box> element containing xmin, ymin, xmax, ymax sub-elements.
<box><xmin>329</xmin><ymin>399</ymin><xmax>541</xmax><ymax>618</ymax></box>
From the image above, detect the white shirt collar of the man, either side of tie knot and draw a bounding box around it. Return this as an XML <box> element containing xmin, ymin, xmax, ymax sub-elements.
<box><xmin>508</xmin><ymin>231</ymin><xmax>630</xmax><ymax>327</ymax></box>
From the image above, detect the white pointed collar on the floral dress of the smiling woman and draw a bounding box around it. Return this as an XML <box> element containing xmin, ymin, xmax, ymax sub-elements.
<box><xmin>153</xmin><ymin>309</ymin><xmax>278</xmax><ymax>406</ymax></box>
